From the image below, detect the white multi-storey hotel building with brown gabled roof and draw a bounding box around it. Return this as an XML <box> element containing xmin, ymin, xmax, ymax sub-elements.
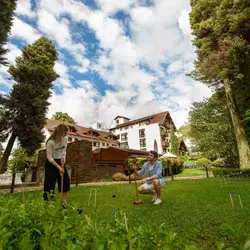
<box><xmin>110</xmin><ymin>111</ymin><xmax>187</xmax><ymax>155</ymax></box>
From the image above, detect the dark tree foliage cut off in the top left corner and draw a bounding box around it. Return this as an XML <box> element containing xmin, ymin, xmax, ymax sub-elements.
<box><xmin>0</xmin><ymin>0</ymin><xmax>16</xmax><ymax>65</ymax></box>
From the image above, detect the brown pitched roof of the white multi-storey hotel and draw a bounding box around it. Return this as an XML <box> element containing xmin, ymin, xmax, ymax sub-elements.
<box><xmin>111</xmin><ymin>111</ymin><xmax>175</xmax><ymax>130</ymax></box>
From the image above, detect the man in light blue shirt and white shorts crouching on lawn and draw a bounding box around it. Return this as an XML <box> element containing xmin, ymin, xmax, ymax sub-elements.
<box><xmin>133</xmin><ymin>151</ymin><xmax>165</xmax><ymax>205</ymax></box>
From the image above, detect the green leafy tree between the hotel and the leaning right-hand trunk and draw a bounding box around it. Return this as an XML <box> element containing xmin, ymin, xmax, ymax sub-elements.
<box><xmin>185</xmin><ymin>92</ymin><xmax>238</xmax><ymax>166</ymax></box>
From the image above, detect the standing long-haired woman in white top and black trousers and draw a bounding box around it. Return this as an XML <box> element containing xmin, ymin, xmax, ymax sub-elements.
<box><xmin>43</xmin><ymin>124</ymin><xmax>70</xmax><ymax>208</ymax></box>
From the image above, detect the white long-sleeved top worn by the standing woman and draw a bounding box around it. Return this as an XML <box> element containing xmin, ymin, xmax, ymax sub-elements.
<box><xmin>46</xmin><ymin>136</ymin><xmax>68</xmax><ymax>162</ymax></box>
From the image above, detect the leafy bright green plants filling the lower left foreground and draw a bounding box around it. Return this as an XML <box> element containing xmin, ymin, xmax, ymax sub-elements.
<box><xmin>0</xmin><ymin>197</ymin><xmax>191</xmax><ymax>250</ymax></box>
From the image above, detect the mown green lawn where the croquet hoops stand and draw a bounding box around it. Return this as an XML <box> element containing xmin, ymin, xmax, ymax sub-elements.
<box><xmin>10</xmin><ymin>178</ymin><xmax>250</xmax><ymax>249</ymax></box>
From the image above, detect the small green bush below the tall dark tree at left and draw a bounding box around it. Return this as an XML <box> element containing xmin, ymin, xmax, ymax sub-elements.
<box><xmin>8</xmin><ymin>147</ymin><xmax>28</xmax><ymax>172</ymax></box>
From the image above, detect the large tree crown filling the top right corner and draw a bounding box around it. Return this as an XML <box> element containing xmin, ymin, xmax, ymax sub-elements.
<box><xmin>190</xmin><ymin>0</ymin><xmax>250</xmax><ymax>86</ymax></box>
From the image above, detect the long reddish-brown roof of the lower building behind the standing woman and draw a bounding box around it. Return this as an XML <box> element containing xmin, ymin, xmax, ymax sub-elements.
<box><xmin>45</xmin><ymin>119</ymin><xmax>119</xmax><ymax>144</ymax></box>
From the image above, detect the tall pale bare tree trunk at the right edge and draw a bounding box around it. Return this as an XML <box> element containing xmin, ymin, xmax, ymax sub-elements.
<box><xmin>224</xmin><ymin>79</ymin><xmax>250</xmax><ymax>168</ymax></box>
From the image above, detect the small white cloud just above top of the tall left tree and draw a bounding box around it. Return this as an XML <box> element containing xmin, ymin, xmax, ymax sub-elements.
<box><xmin>11</xmin><ymin>17</ymin><xmax>41</xmax><ymax>43</ymax></box>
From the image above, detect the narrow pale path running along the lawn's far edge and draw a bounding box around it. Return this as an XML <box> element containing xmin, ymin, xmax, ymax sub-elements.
<box><xmin>0</xmin><ymin>176</ymin><xmax>211</xmax><ymax>194</ymax></box>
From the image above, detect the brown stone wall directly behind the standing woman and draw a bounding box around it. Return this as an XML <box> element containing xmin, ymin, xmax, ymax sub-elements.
<box><xmin>37</xmin><ymin>140</ymin><xmax>94</xmax><ymax>184</ymax></box>
